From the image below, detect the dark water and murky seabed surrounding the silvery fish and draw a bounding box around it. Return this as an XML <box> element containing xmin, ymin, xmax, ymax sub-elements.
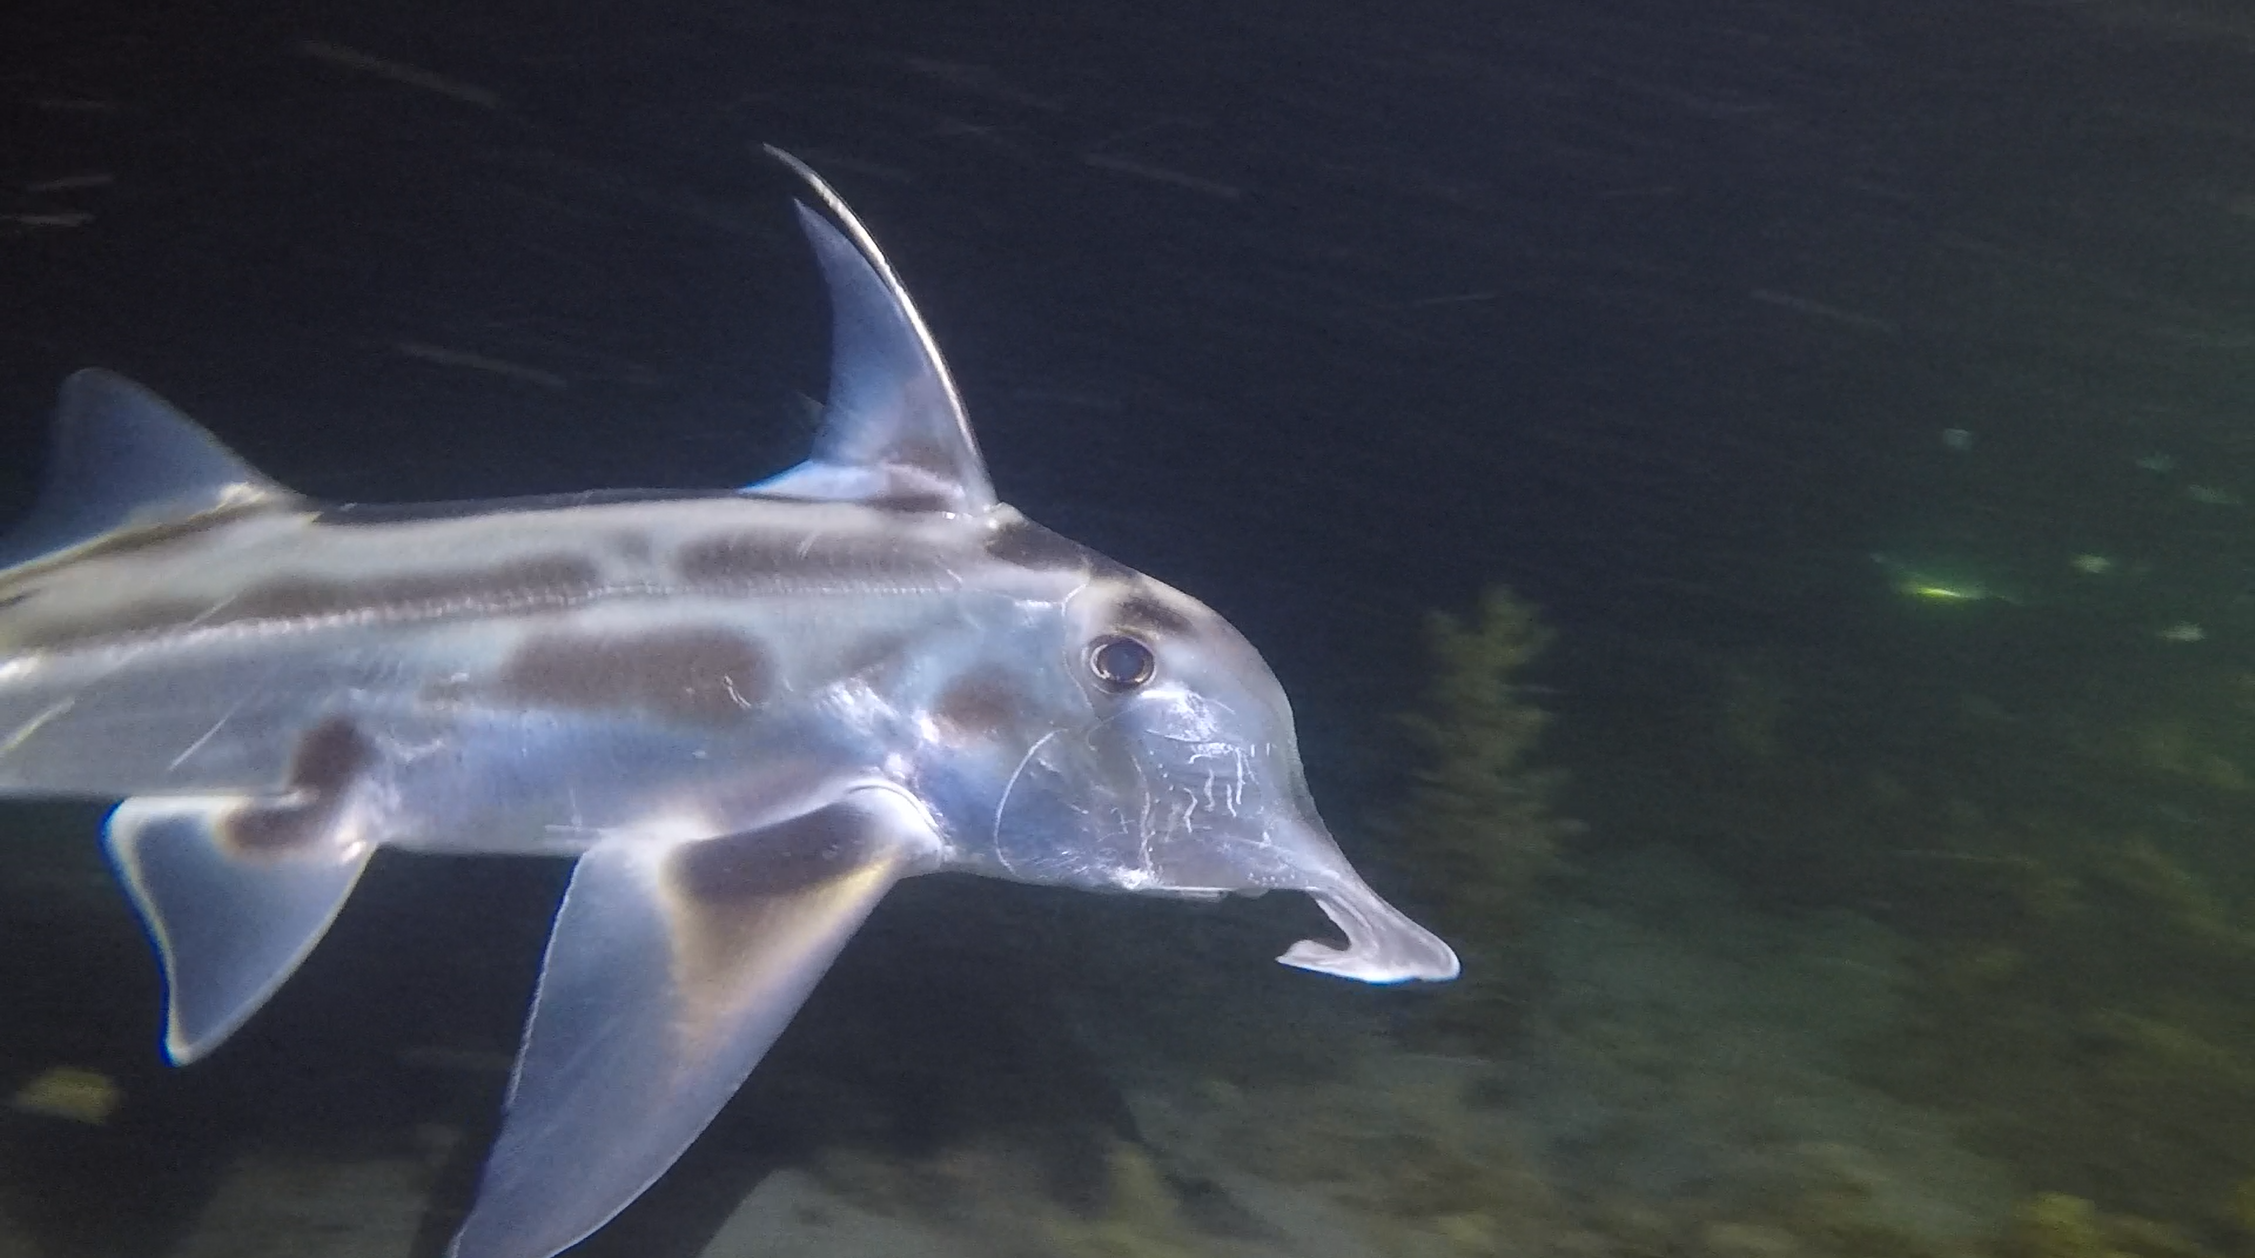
<box><xmin>0</xmin><ymin>0</ymin><xmax>2255</xmax><ymax>1258</ymax></box>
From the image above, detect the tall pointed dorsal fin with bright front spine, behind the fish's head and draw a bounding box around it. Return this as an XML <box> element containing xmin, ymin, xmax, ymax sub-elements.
<box><xmin>749</xmin><ymin>147</ymin><xmax>994</xmax><ymax>514</ymax></box>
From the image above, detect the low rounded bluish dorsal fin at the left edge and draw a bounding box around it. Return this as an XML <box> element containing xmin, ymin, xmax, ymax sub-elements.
<box><xmin>0</xmin><ymin>370</ymin><xmax>295</xmax><ymax>568</ymax></box>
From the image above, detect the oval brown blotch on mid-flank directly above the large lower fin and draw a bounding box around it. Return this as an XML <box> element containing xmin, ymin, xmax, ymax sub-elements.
<box><xmin>494</xmin><ymin>627</ymin><xmax>773</xmax><ymax>724</ymax></box>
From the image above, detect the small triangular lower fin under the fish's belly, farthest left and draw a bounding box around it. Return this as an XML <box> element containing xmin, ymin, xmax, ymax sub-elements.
<box><xmin>104</xmin><ymin>796</ymin><xmax>370</xmax><ymax>1064</ymax></box>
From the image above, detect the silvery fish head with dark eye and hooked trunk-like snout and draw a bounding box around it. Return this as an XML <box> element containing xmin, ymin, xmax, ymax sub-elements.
<box><xmin>942</xmin><ymin>523</ymin><xmax>1457</xmax><ymax>983</ymax></box>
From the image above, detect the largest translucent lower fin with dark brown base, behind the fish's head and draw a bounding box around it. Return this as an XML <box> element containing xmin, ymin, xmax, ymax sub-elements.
<box><xmin>451</xmin><ymin>789</ymin><xmax>938</xmax><ymax>1258</ymax></box>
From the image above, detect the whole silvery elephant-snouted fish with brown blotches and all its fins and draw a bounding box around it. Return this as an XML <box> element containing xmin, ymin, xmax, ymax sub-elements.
<box><xmin>0</xmin><ymin>158</ymin><xmax>1457</xmax><ymax>1258</ymax></box>
